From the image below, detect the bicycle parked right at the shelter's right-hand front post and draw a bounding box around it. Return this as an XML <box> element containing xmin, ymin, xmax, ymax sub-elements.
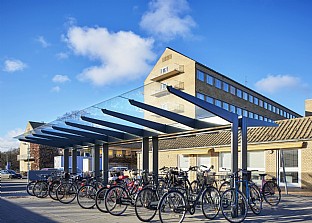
<box><xmin>221</xmin><ymin>170</ymin><xmax>262</xmax><ymax>222</ymax></box>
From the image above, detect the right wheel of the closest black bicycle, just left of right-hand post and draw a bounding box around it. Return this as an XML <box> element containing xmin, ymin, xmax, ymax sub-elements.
<box><xmin>202</xmin><ymin>186</ymin><xmax>220</xmax><ymax>219</ymax></box>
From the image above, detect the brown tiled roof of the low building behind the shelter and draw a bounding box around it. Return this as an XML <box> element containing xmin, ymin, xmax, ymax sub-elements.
<box><xmin>159</xmin><ymin>116</ymin><xmax>312</xmax><ymax>150</ymax></box>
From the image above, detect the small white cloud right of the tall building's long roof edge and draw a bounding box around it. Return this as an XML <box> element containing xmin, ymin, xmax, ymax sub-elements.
<box><xmin>255</xmin><ymin>75</ymin><xmax>304</xmax><ymax>93</ymax></box>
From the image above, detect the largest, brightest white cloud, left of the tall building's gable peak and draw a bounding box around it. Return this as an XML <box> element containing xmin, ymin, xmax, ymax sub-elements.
<box><xmin>66</xmin><ymin>26</ymin><xmax>155</xmax><ymax>86</ymax></box>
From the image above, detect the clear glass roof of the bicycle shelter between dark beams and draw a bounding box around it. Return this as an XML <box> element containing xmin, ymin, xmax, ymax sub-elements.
<box><xmin>17</xmin><ymin>82</ymin><xmax>229</xmax><ymax>142</ymax></box>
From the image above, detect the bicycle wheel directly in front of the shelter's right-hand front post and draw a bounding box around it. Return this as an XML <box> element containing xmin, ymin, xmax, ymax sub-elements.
<box><xmin>220</xmin><ymin>188</ymin><xmax>248</xmax><ymax>222</ymax></box>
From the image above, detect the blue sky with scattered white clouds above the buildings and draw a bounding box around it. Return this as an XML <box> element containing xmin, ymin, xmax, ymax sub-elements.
<box><xmin>0</xmin><ymin>0</ymin><xmax>312</xmax><ymax>151</ymax></box>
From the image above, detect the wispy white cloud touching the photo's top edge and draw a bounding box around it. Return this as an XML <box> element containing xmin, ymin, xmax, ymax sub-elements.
<box><xmin>140</xmin><ymin>0</ymin><xmax>196</xmax><ymax>40</ymax></box>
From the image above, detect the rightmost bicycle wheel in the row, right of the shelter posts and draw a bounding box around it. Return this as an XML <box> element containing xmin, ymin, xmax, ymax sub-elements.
<box><xmin>262</xmin><ymin>180</ymin><xmax>281</xmax><ymax>206</ymax></box>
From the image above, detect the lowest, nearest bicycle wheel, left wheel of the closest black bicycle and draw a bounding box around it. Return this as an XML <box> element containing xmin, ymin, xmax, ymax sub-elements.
<box><xmin>158</xmin><ymin>191</ymin><xmax>186</xmax><ymax>223</ymax></box>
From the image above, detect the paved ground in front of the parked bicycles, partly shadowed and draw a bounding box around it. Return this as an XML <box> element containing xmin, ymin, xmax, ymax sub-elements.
<box><xmin>0</xmin><ymin>180</ymin><xmax>312</xmax><ymax>223</ymax></box>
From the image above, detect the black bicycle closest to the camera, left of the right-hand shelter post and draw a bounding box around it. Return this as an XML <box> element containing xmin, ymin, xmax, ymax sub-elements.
<box><xmin>158</xmin><ymin>168</ymin><xmax>220</xmax><ymax>223</ymax></box>
